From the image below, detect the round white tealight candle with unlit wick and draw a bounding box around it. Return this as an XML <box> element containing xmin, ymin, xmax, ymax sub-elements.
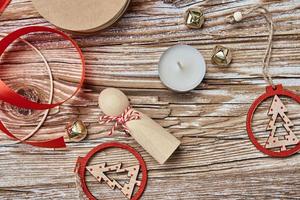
<box><xmin>158</xmin><ymin>45</ymin><xmax>206</xmax><ymax>92</ymax></box>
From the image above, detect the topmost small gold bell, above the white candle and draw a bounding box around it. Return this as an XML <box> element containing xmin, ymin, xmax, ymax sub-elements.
<box><xmin>184</xmin><ymin>7</ymin><xmax>205</xmax><ymax>28</ymax></box>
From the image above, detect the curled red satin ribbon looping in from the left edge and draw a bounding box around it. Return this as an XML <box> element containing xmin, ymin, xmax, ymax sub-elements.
<box><xmin>0</xmin><ymin>26</ymin><xmax>85</xmax><ymax>148</ymax></box>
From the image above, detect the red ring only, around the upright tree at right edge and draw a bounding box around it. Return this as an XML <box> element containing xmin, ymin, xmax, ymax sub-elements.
<box><xmin>246</xmin><ymin>84</ymin><xmax>300</xmax><ymax>157</ymax></box>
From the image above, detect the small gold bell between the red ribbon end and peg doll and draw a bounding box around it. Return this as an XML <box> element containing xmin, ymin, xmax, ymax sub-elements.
<box><xmin>66</xmin><ymin>120</ymin><xmax>87</xmax><ymax>142</ymax></box>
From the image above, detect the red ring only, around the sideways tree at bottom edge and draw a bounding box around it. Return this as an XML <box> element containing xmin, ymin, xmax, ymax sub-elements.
<box><xmin>76</xmin><ymin>142</ymin><xmax>148</xmax><ymax>200</ymax></box>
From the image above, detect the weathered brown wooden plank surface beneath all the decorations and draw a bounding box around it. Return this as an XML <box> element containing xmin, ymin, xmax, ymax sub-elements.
<box><xmin>0</xmin><ymin>0</ymin><xmax>300</xmax><ymax>200</ymax></box>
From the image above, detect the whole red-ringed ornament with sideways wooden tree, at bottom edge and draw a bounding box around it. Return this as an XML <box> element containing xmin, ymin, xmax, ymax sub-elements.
<box><xmin>75</xmin><ymin>142</ymin><xmax>148</xmax><ymax>200</ymax></box>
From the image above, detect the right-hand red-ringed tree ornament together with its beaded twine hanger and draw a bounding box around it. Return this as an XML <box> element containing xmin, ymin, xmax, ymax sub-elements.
<box><xmin>233</xmin><ymin>5</ymin><xmax>300</xmax><ymax>157</ymax></box>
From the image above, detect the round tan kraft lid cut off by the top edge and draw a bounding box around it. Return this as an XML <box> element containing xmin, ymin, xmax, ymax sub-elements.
<box><xmin>32</xmin><ymin>0</ymin><xmax>130</xmax><ymax>33</ymax></box>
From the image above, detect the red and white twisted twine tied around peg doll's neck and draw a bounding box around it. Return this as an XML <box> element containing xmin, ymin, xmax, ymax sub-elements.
<box><xmin>99</xmin><ymin>106</ymin><xmax>141</xmax><ymax>135</ymax></box>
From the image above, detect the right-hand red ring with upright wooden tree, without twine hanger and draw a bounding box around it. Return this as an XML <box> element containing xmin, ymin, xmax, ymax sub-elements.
<box><xmin>246</xmin><ymin>85</ymin><xmax>300</xmax><ymax>157</ymax></box>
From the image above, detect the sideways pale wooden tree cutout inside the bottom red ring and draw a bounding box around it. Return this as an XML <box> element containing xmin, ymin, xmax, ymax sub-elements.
<box><xmin>86</xmin><ymin>163</ymin><xmax>141</xmax><ymax>199</ymax></box>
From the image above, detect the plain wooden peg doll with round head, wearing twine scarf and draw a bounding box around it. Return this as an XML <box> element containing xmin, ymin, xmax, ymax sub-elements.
<box><xmin>99</xmin><ymin>88</ymin><xmax>180</xmax><ymax>164</ymax></box>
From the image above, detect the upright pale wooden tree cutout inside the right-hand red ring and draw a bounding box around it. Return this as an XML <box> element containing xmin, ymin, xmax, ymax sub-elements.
<box><xmin>265</xmin><ymin>95</ymin><xmax>299</xmax><ymax>151</ymax></box>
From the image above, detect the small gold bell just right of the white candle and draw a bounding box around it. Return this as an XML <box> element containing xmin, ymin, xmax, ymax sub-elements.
<box><xmin>211</xmin><ymin>45</ymin><xmax>232</xmax><ymax>66</ymax></box>
